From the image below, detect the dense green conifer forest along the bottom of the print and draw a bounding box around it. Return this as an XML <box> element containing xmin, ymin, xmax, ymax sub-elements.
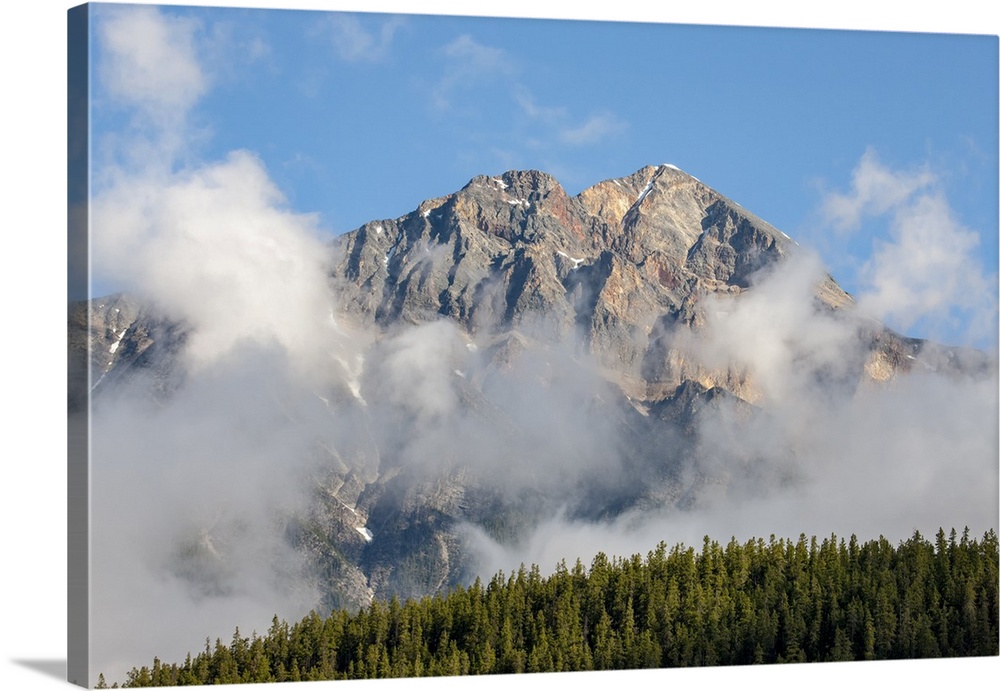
<box><xmin>105</xmin><ymin>529</ymin><xmax>998</xmax><ymax>688</ymax></box>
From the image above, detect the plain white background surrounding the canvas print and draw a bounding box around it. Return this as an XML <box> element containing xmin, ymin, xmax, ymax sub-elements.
<box><xmin>0</xmin><ymin>0</ymin><xmax>1000</xmax><ymax>690</ymax></box>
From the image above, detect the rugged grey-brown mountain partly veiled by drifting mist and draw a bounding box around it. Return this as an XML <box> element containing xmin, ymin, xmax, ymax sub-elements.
<box><xmin>69</xmin><ymin>165</ymin><xmax>989</xmax><ymax>606</ymax></box>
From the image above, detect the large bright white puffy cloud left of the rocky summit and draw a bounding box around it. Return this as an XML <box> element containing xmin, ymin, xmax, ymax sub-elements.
<box><xmin>92</xmin><ymin>151</ymin><xmax>344</xmax><ymax>378</ymax></box>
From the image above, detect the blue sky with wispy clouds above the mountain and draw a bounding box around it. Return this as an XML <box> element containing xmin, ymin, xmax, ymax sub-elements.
<box><xmin>92</xmin><ymin>5</ymin><xmax>998</xmax><ymax>352</ymax></box>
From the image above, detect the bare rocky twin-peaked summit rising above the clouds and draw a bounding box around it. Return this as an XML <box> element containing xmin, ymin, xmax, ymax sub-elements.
<box><xmin>334</xmin><ymin>165</ymin><xmax>851</xmax><ymax>398</ymax></box>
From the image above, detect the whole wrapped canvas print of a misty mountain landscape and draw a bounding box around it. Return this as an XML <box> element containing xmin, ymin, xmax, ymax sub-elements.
<box><xmin>68</xmin><ymin>3</ymin><xmax>1000</xmax><ymax>688</ymax></box>
